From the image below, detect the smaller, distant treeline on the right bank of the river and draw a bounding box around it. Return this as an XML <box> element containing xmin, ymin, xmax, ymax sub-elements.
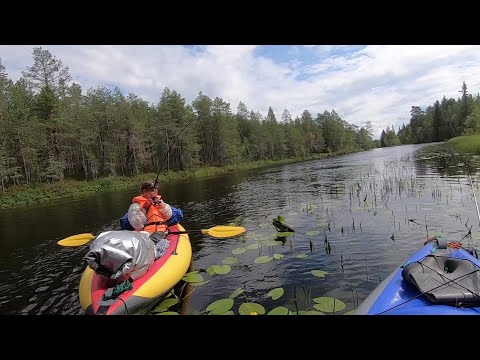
<box><xmin>380</xmin><ymin>82</ymin><xmax>480</xmax><ymax>147</ymax></box>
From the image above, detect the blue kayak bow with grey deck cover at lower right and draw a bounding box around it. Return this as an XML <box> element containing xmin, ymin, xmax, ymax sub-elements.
<box><xmin>353</xmin><ymin>241</ymin><xmax>480</xmax><ymax>315</ymax></box>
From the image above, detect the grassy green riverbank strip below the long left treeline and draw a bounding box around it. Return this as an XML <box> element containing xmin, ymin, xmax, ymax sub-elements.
<box><xmin>0</xmin><ymin>152</ymin><xmax>360</xmax><ymax>209</ymax></box>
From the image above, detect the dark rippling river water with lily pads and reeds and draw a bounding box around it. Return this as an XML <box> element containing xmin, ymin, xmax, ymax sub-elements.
<box><xmin>0</xmin><ymin>145</ymin><xmax>480</xmax><ymax>315</ymax></box>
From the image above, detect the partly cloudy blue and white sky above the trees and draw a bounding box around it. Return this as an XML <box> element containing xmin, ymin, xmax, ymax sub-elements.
<box><xmin>0</xmin><ymin>45</ymin><xmax>480</xmax><ymax>139</ymax></box>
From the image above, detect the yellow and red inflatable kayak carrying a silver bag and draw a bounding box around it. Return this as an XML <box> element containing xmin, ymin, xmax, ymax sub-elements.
<box><xmin>79</xmin><ymin>224</ymin><xmax>192</xmax><ymax>315</ymax></box>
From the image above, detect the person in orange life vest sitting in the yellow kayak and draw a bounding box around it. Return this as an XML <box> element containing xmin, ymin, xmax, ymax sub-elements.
<box><xmin>128</xmin><ymin>181</ymin><xmax>172</xmax><ymax>233</ymax></box>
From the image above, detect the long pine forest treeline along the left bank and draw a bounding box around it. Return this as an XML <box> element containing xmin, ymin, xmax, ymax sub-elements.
<box><xmin>0</xmin><ymin>47</ymin><xmax>378</xmax><ymax>192</ymax></box>
